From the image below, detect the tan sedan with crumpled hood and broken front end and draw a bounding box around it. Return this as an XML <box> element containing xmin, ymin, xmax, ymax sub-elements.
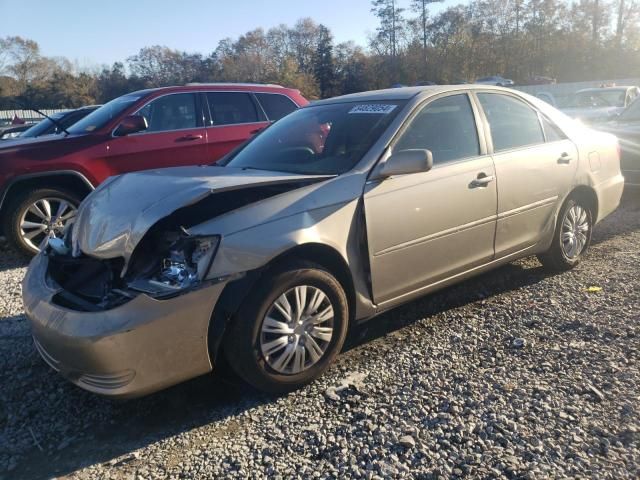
<box><xmin>23</xmin><ymin>86</ymin><xmax>623</xmax><ymax>397</ymax></box>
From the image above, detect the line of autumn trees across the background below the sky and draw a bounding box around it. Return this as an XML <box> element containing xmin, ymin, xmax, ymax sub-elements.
<box><xmin>0</xmin><ymin>0</ymin><xmax>640</xmax><ymax>109</ymax></box>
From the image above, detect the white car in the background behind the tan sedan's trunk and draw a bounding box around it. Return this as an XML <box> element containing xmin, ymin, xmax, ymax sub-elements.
<box><xmin>561</xmin><ymin>86</ymin><xmax>640</xmax><ymax>123</ymax></box>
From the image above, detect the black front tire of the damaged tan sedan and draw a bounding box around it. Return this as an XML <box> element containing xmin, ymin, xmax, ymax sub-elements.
<box><xmin>222</xmin><ymin>263</ymin><xmax>349</xmax><ymax>393</ymax></box>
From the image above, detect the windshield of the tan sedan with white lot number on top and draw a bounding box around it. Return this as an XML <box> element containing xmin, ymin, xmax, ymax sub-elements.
<box><xmin>227</xmin><ymin>101</ymin><xmax>404</xmax><ymax>175</ymax></box>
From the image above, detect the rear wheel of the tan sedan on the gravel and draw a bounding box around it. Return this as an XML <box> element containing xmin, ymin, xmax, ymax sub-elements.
<box><xmin>538</xmin><ymin>197</ymin><xmax>593</xmax><ymax>272</ymax></box>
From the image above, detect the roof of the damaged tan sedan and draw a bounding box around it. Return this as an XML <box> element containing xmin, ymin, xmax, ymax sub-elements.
<box><xmin>313</xmin><ymin>84</ymin><xmax>513</xmax><ymax>107</ymax></box>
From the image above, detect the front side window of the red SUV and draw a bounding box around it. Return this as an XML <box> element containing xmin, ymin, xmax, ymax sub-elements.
<box><xmin>138</xmin><ymin>93</ymin><xmax>197</xmax><ymax>132</ymax></box>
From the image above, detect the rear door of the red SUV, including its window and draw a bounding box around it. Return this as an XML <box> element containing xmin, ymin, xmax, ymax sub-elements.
<box><xmin>204</xmin><ymin>92</ymin><xmax>269</xmax><ymax>163</ymax></box>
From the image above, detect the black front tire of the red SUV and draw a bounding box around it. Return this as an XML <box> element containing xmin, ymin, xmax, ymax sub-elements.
<box><xmin>3</xmin><ymin>188</ymin><xmax>82</xmax><ymax>256</ymax></box>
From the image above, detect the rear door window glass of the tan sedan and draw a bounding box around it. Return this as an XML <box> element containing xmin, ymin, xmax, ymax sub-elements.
<box><xmin>478</xmin><ymin>93</ymin><xmax>544</xmax><ymax>152</ymax></box>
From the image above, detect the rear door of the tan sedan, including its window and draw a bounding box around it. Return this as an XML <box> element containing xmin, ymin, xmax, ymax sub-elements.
<box><xmin>476</xmin><ymin>92</ymin><xmax>578</xmax><ymax>257</ymax></box>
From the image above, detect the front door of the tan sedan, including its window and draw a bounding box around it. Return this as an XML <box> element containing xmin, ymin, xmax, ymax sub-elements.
<box><xmin>364</xmin><ymin>93</ymin><xmax>497</xmax><ymax>305</ymax></box>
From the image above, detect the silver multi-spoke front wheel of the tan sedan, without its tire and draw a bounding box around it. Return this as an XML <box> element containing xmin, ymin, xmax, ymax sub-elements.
<box><xmin>260</xmin><ymin>285</ymin><xmax>334</xmax><ymax>375</ymax></box>
